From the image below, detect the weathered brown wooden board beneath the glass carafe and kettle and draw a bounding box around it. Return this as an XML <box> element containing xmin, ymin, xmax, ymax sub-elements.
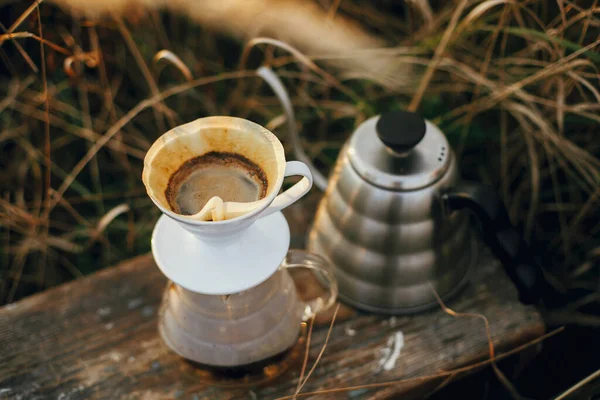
<box><xmin>0</xmin><ymin>192</ymin><xmax>544</xmax><ymax>399</ymax></box>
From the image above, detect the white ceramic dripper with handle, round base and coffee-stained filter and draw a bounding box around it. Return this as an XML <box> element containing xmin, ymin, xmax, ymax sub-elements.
<box><xmin>142</xmin><ymin>117</ymin><xmax>312</xmax><ymax>295</ymax></box>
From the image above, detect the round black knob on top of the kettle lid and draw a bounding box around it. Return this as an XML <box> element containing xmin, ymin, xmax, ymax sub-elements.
<box><xmin>375</xmin><ymin>110</ymin><xmax>426</xmax><ymax>153</ymax></box>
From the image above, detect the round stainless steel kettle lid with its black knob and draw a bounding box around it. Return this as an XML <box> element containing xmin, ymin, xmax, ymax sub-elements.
<box><xmin>348</xmin><ymin>110</ymin><xmax>451</xmax><ymax>190</ymax></box>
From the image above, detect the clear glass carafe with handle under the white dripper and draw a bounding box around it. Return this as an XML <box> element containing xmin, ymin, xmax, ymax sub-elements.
<box><xmin>159</xmin><ymin>250</ymin><xmax>337</xmax><ymax>384</ymax></box>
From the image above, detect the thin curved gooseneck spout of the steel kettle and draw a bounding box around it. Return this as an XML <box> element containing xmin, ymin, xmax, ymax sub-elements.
<box><xmin>256</xmin><ymin>66</ymin><xmax>327</xmax><ymax>191</ymax></box>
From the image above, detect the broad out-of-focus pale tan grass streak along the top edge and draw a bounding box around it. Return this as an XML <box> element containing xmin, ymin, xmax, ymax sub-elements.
<box><xmin>47</xmin><ymin>0</ymin><xmax>398</xmax><ymax>86</ymax></box>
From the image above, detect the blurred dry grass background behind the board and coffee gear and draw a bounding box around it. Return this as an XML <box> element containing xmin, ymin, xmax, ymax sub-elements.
<box><xmin>0</xmin><ymin>0</ymin><xmax>600</xmax><ymax>398</ymax></box>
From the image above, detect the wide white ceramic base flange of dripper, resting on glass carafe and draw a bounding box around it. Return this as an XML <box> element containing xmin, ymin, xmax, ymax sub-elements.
<box><xmin>152</xmin><ymin>212</ymin><xmax>290</xmax><ymax>295</ymax></box>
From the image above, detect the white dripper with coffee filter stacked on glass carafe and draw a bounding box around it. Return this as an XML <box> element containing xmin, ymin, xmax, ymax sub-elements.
<box><xmin>142</xmin><ymin>117</ymin><xmax>337</xmax><ymax>383</ymax></box>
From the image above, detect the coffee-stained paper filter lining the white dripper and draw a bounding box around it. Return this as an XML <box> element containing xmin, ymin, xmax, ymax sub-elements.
<box><xmin>142</xmin><ymin>116</ymin><xmax>285</xmax><ymax>220</ymax></box>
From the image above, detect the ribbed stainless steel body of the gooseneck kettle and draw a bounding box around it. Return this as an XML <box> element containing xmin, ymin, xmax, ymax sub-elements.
<box><xmin>307</xmin><ymin>117</ymin><xmax>477</xmax><ymax>314</ymax></box>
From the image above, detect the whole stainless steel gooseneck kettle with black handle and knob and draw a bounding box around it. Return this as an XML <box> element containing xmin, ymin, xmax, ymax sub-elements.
<box><xmin>259</xmin><ymin>69</ymin><xmax>547</xmax><ymax>314</ymax></box>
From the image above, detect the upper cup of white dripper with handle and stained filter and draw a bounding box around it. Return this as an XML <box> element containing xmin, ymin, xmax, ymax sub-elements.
<box><xmin>142</xmin><ymin>116</ymin><xmax>312</xmax><ymax>242</ymax></box>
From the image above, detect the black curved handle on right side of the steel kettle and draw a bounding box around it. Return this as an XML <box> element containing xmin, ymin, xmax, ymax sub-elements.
<box><xmin>442</xmin><ymin>182</ymin><xmax>556</xmax><ymax>304</ymax></box>
